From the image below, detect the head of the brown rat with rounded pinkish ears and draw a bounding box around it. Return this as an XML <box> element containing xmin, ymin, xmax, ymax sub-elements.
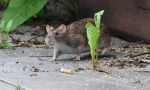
<box><xmin>45</xmin><ymin>24</ymin><xmax>66</xmax><ymax>44</ymax></box>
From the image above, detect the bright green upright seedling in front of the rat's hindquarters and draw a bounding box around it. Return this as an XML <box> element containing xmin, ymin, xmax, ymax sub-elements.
<box><xmin>85</xmin><ymin>10</ymin><xmax>104</xmax><ymax>68</ymax></box>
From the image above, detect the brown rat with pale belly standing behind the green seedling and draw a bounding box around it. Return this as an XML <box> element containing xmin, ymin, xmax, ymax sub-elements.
<box><xmin>45</xmin><ymin>18</ymin><xmax>110</xmax><ymax>61</ymax></box>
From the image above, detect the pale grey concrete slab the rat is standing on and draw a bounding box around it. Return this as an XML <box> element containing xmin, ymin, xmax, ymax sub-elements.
<box><xmin>0</xmin><ymin>47</ymin><xmax>150</xmax><ymax>90</ymax></box>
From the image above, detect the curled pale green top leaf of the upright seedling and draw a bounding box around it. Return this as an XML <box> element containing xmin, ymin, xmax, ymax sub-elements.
<box><xmin>94</xmin><ymin>10</ymin><xmax>104</xmax><ymax>28</ymax></box>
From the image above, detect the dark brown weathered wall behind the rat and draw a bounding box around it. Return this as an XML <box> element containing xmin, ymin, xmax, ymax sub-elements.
<box><xmin>80</xmin><ymin>0</ymin><xmax>150</xmax><ymax>41</ymax></box>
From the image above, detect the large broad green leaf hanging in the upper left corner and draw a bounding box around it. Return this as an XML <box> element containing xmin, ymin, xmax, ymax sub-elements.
<box><xmin>0</xmin><ymin>0</ymin><xmax>47</xmax><ymax>32</ymax></box>
